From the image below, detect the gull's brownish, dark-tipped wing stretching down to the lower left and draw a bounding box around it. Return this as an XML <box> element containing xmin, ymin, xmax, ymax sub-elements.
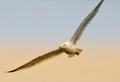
<box><xmin>8</xmin><ymin>49</ymin><xmax>62</xmax><ymax>73</ymax></box>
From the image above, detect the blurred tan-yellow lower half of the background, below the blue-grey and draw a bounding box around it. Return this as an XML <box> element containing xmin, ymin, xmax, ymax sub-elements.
<box><xmin>0</xmin><ymin>42</ymin><xmax>120</xmax><ymax>82</ymax></box>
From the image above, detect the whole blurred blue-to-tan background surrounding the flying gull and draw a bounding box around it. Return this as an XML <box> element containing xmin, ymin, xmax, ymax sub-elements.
<box><xmin>0</xmin><ymin>0</ymin><xmax>120</xmax><ymax>82</ymax></box>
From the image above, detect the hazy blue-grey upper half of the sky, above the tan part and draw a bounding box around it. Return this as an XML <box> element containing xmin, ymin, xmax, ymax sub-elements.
<box><xmin>0</xmin><ymin>0</ymin><xmax>120</xmax><ymax>47</ymax></box>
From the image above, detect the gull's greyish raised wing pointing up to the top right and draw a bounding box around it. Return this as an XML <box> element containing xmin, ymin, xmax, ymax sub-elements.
<box><xmin>70</xmin><ymin>0</ymin><xmax>104</xmax><ymax>44</ymax></box>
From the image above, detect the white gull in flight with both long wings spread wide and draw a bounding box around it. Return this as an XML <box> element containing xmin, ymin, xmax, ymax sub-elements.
<box><xmin>8</xmin><ymin>0</ymin><xmax>104</xmax><ymax>73</ymax></box>
